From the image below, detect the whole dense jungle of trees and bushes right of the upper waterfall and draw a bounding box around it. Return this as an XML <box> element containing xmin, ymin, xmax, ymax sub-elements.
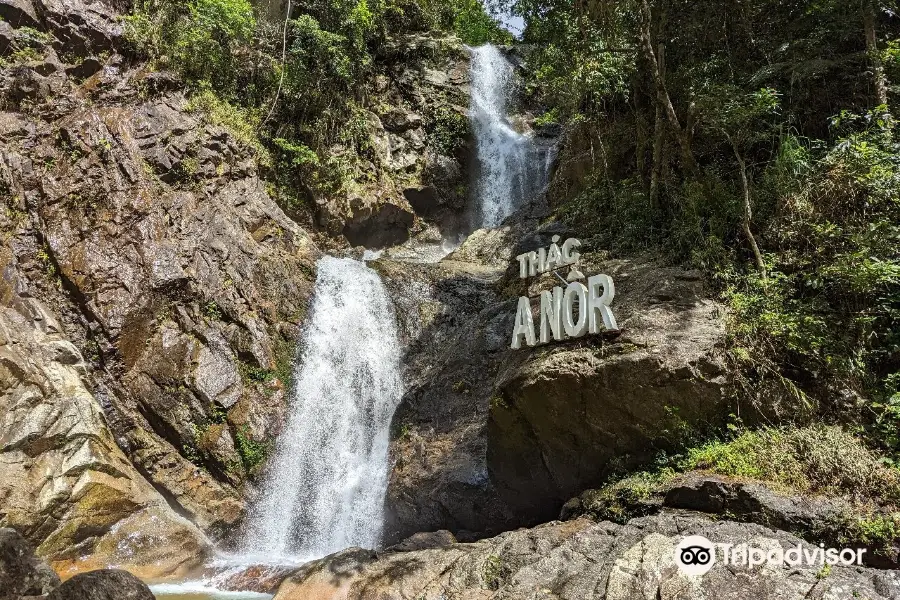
<box><xmin>502</xmin><ymin>0</ymin><xmax>900</xmax><ymax>463</ymax></box>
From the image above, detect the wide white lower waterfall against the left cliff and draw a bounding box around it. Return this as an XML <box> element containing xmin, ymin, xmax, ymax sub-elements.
<box><xmin>241</xmin><ymin>257</ymin><xmax>402</xmax><ymax>564</ymax></box>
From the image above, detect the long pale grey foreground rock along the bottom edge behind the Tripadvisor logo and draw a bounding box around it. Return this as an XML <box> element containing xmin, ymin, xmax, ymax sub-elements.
<box><xmin>275</xmin><ymin>513</ymin><xmax>900</xmax><ymax>600</ymax></box>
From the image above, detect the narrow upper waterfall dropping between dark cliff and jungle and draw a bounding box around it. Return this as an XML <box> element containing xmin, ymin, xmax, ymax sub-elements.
<box><xmin>469</xmin><ymin>44</ymin><xmax>546</xmax><ymax>227</ymax></box>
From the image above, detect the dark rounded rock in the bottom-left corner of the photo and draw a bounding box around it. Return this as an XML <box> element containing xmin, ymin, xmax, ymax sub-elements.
<box><xmin>0</xmin><ymin>529</ymin><xmax>59</xmax><ymax>600</ymax></box>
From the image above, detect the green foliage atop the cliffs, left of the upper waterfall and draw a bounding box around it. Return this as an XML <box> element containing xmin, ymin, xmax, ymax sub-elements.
<box><xmin>127</xmin><ymin>0</ymin><xmax>511</xmax><ymax>219</ymax></box>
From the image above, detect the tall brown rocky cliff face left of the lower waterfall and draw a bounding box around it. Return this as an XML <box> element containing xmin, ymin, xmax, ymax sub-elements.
<box><xmin>0</xmin><ymin>0</ymin><xmax>318</xmax><ymax>566</ymax></box>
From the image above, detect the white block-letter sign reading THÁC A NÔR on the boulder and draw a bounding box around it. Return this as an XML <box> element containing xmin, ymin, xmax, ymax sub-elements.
<box><xmin>512</xmin><ymin>236</ymin><xmax>619</xmax><ymax>350</ymax></box>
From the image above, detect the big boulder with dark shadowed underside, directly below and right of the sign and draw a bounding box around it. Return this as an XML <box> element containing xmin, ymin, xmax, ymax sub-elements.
<box><xmin>487</xmin><ymin>254</ymin><xmax>731</xmax><ymax>520</ymax></box>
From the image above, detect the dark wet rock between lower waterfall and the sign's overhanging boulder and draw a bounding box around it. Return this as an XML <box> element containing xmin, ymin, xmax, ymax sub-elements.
<box><xmin>373</xmin><ymin>254</ymin><xmax>517</xmax><ymax>544</ymax></box>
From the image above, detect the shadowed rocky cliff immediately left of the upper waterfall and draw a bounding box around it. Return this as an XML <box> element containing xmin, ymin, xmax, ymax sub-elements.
<box><xmin>317</xmin><ymin>35</ymin><xmax>470</xmax><ymax>249</ymax></box>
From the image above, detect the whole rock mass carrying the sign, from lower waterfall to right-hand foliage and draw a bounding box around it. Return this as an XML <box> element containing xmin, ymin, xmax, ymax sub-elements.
<box><xmin>374</xmin><ymin>221</ymin><xmax>730</xmax><ymax>543</ymax></box>
